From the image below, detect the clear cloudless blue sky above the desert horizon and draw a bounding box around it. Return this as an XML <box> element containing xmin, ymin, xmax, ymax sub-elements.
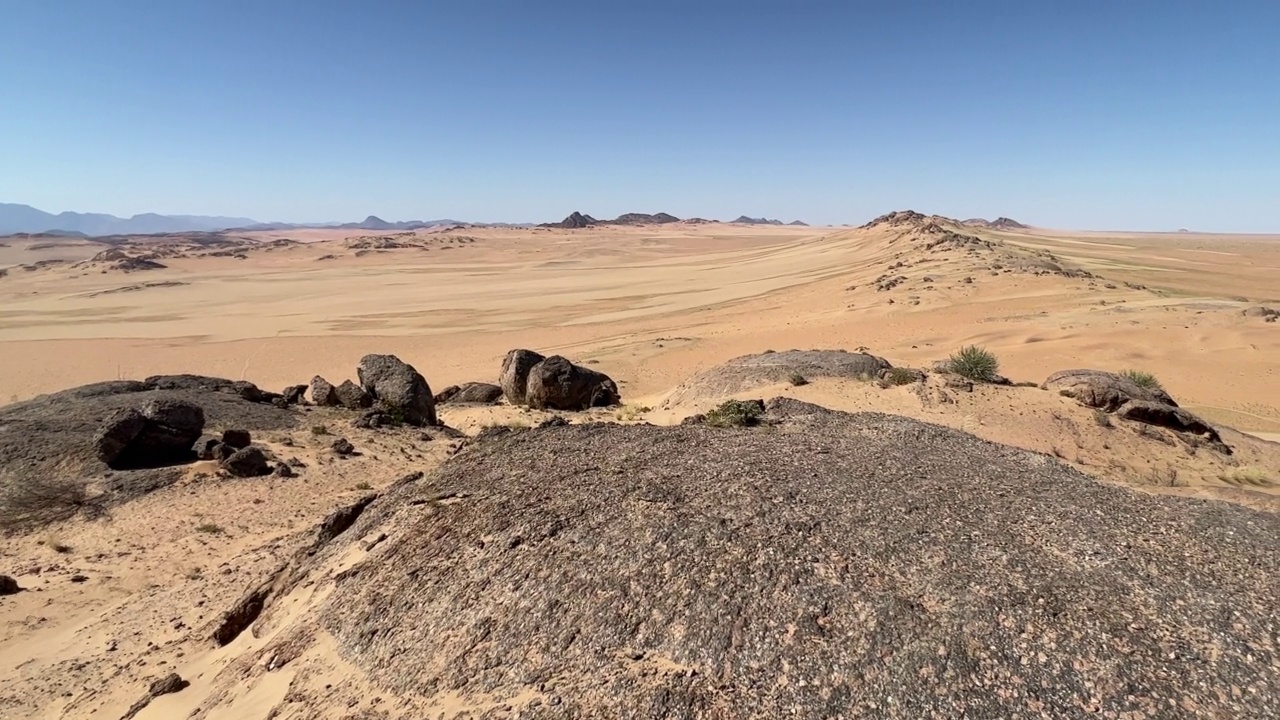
<box><xmin>0</xmin><ymin>0</ymin><xmax>1280</xmax><ymax>232</ymax></box>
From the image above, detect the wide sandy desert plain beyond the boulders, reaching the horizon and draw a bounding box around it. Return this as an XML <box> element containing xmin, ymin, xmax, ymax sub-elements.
<box><xmin>0</xmin><ymin>219</ymin><xmax>1280</xmax><ymax>434</ymax></box>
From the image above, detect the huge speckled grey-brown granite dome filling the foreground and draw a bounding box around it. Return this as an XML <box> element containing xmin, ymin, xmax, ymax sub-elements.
<box><xmin>267</xmin><ymin>401</ymin><xmax>1280</xmax><ymax>720</ymax></box>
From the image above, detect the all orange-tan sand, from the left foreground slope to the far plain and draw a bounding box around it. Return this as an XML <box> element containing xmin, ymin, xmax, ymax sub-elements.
<box><xmin>0</xmin><ymin>215</ymin><xmax>1280</xmax><ymax>719</ymax></box>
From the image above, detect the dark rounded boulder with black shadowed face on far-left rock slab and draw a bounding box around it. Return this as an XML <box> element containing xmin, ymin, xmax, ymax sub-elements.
<box><xmin>93</xmin><ymin>400</ymin><xmax>205</xmax><ymax>470</ymax></box>
